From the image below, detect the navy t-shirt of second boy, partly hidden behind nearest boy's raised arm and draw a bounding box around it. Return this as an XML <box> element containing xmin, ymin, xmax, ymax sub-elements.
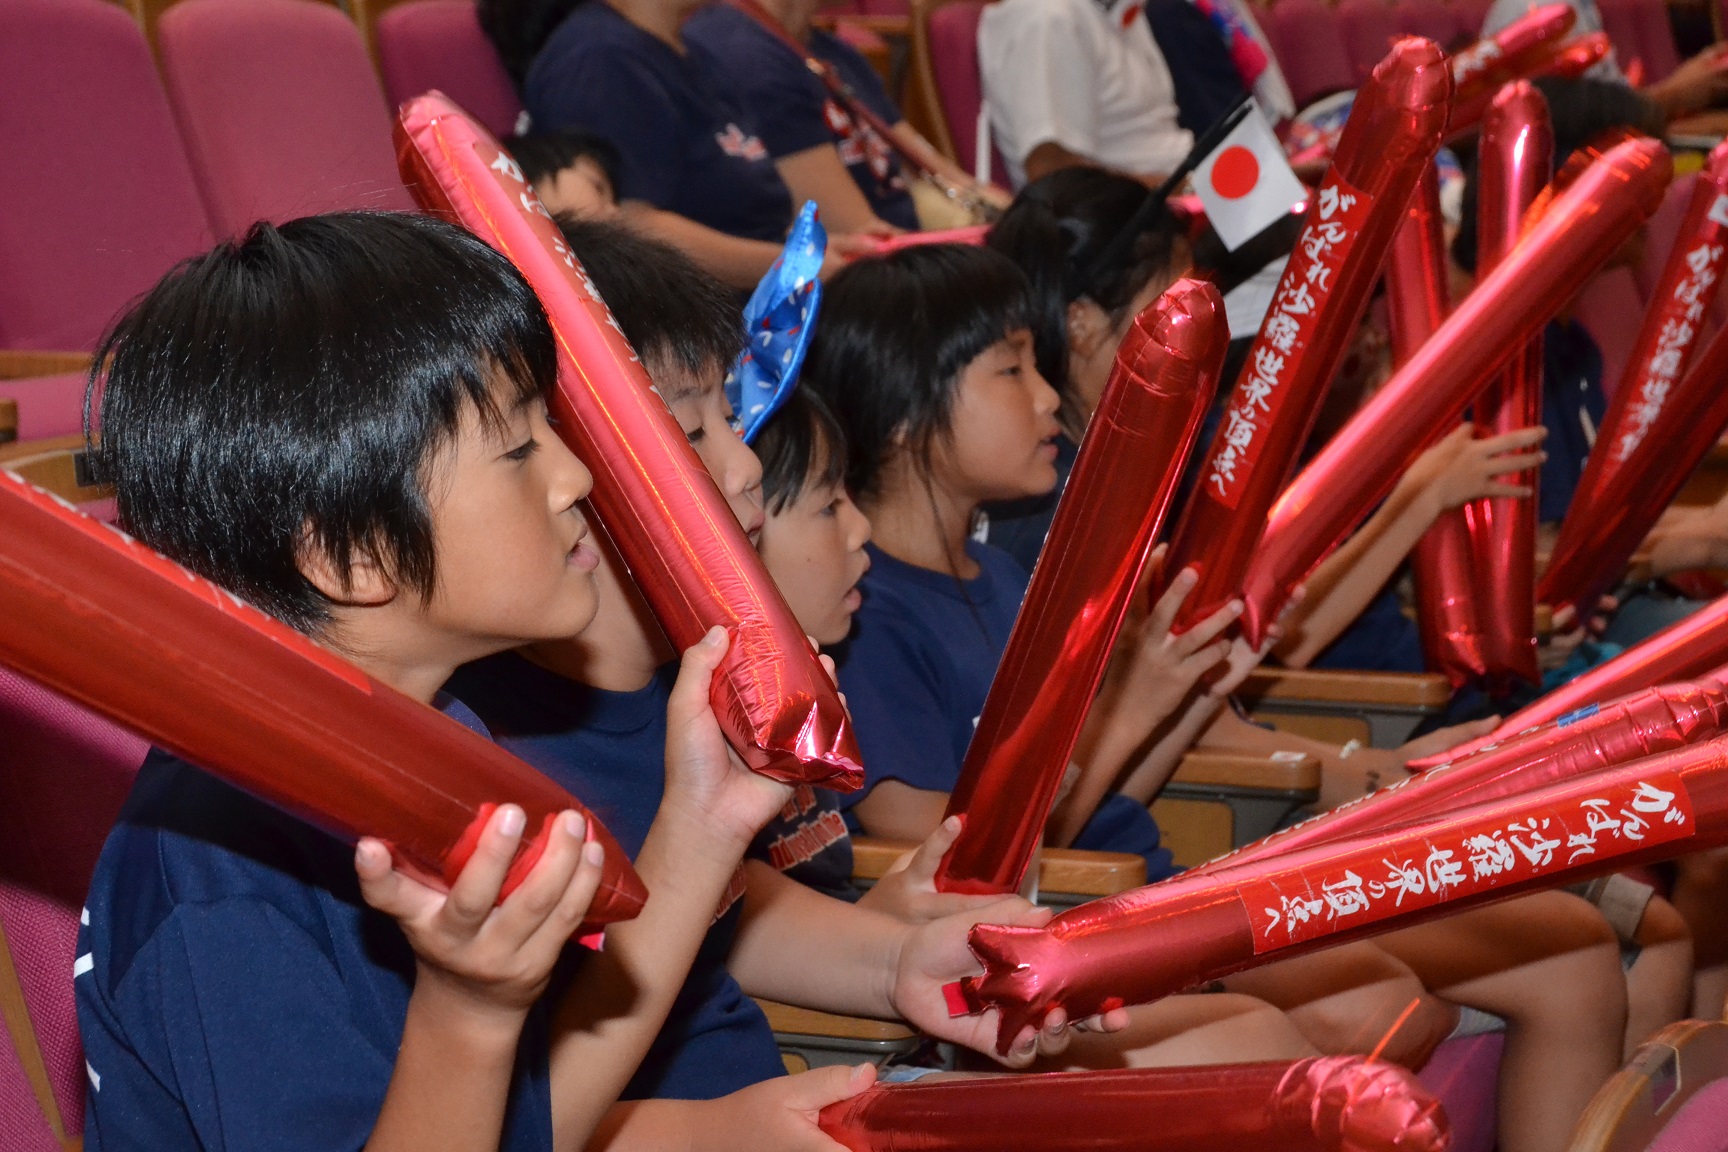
<box><xmin>438</xmin><ymin>653</ymin><xmax>786</xmax><ymax>1100</ymax></box>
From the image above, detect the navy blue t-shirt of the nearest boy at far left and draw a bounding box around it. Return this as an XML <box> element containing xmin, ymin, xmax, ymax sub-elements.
<box><xmin>73</xmin><ymin>705</ymin><xmax>575</xmax><ymax>1152</ymax></box>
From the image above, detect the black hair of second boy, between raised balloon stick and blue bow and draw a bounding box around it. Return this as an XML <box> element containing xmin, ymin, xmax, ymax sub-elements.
<box><xmin>558</xmin><ymin>214</ymin><xmax>745</xmax><ymax>392</ymax></box>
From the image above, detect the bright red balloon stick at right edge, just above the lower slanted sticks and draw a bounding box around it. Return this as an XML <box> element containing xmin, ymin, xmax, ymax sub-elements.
<box><xmin>1430</xmin><ymin>611</ymin><xmax>1728</xmax><ymax>769</ymax></box>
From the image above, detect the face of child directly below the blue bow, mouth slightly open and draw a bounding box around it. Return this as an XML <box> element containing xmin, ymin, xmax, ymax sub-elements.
<box><xmin>759</xmin><ymin>459</ymin><xmax>869</xmax><ymax>644</ymax></box>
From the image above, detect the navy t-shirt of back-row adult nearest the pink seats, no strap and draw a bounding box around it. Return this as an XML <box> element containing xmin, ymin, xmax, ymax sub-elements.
<box><xmin>524</xmin><ymin>0</ymin><xmax>791</xmax><ymax>244</ymax></box>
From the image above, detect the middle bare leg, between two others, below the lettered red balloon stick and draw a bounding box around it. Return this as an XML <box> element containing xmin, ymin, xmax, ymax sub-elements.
<box><xmin>1222</xmin><ymin>941</ymin><xmax>1458</xmax><ymax>1067</ymax></box>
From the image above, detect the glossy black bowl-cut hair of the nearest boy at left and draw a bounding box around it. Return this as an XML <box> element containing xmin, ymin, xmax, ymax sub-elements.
<box><xmin>86</xmin><ymin>212</ymin><xmax>556</xmax><ymax>632</ymax></box>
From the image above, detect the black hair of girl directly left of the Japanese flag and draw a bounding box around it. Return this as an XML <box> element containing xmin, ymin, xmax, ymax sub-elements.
<box><xmin>985</xmin><ymin>168</ymin><xmax>1182</xmax><ymax>399</ymax></box>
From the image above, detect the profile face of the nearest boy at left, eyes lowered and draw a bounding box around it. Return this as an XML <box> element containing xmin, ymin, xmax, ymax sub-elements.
<box><xmin>422</xmin><ymin>373</ymin><xmax>600</xmax><ymax>660</ymax></box>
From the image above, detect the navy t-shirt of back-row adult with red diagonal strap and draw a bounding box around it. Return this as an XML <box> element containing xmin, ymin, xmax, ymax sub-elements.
<box><xmin>684</xmin><ymin>0</ymin><xmax>926</xmax><ymax>230</ymax></box>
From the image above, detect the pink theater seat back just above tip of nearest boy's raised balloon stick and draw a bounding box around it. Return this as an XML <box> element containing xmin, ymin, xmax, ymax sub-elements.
<box><xmin>377</xmin><ymin>0</ymin><xmax>522</xmax><ymax>136</ymax></box>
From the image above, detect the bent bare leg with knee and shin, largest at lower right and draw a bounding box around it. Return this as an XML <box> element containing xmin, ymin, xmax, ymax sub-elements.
<box><xmin>1379</xmin><ymin>891</ymin><xmax>1626</xmax><ymax>1152</ymax></box>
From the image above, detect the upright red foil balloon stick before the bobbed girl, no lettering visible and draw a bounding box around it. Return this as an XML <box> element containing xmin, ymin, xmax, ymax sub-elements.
<box><xmin>937</xmin><ymin>280</ymin><xmax>1230</xmax><ymax>893</ymax></box>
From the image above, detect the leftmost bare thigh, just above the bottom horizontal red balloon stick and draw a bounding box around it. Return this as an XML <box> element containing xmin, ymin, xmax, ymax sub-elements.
<box><xmin>1032</xmin><ymin>993</ymin><xmax>1315</xmax><ymax>1073</ymax></box>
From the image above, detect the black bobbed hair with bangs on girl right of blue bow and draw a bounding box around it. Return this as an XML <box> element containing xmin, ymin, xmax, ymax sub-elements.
<box><xmin>802</xmin><ymin>244</ymin><xmax>1033</xmax><ymax>499</ymax></box>
